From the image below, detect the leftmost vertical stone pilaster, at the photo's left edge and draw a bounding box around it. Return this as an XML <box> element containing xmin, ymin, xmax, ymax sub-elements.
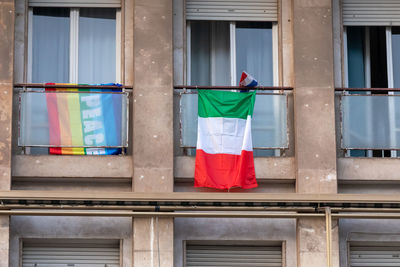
<box><xmin>0</xmin><ymin>0</ymin><xmax>15</xmax><ymax>267</ymax></box>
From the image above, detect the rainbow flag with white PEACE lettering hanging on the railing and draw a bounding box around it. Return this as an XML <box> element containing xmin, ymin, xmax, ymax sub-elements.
<box><xmin>45</xmin><ymin>83</ymin><xmax>123</xmax><ymax>155</ymax></box>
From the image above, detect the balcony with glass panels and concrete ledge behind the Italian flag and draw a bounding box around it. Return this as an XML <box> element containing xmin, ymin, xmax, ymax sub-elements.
<box><xmin>174</xmin><ymin>85</ymin><xmax>295</xmax><ymax>192</ymax></box>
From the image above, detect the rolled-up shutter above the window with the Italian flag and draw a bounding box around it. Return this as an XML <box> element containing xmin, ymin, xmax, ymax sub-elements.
<box><xmin>186</xmin><ymin>0</ymin><xmax>278</xmax><ymax>21</ymax></box>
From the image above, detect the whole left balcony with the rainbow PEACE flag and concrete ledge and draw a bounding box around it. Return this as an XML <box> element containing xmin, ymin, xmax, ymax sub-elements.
<box><xmin>12</xmin><ymin>84</ymin><xmax>132</xmax><ymax>190</ymax></box>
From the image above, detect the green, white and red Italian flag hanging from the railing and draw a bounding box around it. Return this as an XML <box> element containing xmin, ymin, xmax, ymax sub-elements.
<box><xmin>194</xmin><ymin>90</ymin><xmax>257</xmax><ymax>189</ymax></box>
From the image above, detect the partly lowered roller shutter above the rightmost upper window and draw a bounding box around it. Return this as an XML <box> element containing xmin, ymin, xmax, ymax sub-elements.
<box><xmin>342</xmin><ymin>0</ymin><xmax>400</xmax><ymax>26</ymax></box>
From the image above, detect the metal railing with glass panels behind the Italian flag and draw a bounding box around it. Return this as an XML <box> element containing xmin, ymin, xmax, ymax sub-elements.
<box><xmin>174</xmin><ymin>85</ymin><xmax>293</xmax><ymax>150</ymax></box>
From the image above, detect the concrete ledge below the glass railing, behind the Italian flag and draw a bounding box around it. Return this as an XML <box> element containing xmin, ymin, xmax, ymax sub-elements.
<box><xmin>174</xmin><ymin>156</ymin><xmax>295</xmax><ymax>182</ymax></box>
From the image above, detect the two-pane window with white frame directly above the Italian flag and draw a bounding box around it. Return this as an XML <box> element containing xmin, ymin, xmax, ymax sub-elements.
<box><xmin>187</xmin><ymin>21</ymin><xmax>277</xmax><ymax>86</ymax></box>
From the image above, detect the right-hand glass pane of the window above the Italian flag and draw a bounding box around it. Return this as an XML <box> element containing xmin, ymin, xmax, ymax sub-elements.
<box><xmin>236</xmin><ymin>22</ymin><xmax>274</xmax><ymax>86</ymax></box>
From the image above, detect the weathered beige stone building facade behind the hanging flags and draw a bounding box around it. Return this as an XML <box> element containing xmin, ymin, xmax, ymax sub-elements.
<box><xmin>0</xmin><ymin>0</ymin><xmax>400</xmax><ymax>267</ymax></box>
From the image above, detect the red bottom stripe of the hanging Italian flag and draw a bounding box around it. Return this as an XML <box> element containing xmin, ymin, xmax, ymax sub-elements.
<box><xmin>194</xmin><ymin>149</ymin><xmax>258</xmax><ymax>189</ymax></box>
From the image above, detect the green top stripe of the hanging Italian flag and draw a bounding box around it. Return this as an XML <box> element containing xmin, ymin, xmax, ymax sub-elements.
<box><xmin>198</xmin><ymin>90</ymin><xmax>256</xmax><ymax>119</ymax></box>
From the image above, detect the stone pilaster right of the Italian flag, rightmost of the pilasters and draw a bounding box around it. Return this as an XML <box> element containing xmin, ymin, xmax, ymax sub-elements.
<box><xmin>292</xmin><ymin>0</ymin><xmax>339</xmax><ymax>267</ymax></box>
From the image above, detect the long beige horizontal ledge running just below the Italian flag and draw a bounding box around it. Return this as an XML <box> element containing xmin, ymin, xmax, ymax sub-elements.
<box><xmin>0</xmin><ymin>190</ymin><xmax>400</xmax><ymax>204</ymax></box>
